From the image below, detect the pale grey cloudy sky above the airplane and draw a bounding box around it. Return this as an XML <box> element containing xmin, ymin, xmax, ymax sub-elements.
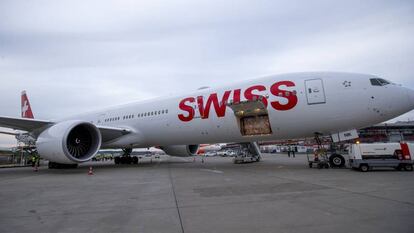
<box><xmin>0</xmin><ymin>0</ymin><xmax>414</xmax><ymax>146</ymax></box>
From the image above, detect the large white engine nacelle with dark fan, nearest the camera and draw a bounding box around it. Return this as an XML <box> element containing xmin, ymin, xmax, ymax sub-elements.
<box><xmin>36</xmin><ymin>121</ymin><xmax>102</xmax><ymax>164</ymax></box>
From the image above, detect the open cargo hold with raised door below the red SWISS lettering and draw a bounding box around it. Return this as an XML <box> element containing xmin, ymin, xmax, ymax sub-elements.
<box><xmin>228</xmin><ymin>99</ymin><xmax>272</xmax><ymax>136</ymax></box>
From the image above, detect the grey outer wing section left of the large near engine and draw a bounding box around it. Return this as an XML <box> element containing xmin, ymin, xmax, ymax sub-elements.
<box><xmin>0</xmin><ymin>116</ymin><xmax>53</xmax><ymax>132</ymax></box>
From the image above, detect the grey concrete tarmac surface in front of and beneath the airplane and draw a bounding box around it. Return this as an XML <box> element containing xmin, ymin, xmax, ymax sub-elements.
<box><xmin>0</xmin><ymin>154</ymin><xmax>414</xmax><ymax>233</ymax></box>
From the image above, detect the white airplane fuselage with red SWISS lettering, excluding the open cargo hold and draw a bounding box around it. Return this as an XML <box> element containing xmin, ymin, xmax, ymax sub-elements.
<box><xmin>59</xmin><ymin>72</ymin><xmax>414</xmax><ymax>148</ymax></box>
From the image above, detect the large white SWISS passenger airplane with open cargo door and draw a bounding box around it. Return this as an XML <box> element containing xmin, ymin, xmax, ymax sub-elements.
<box><xmin>0</xmin><ymin>72</ymin><xmax>414</xmax><ymax>168</ymax></box>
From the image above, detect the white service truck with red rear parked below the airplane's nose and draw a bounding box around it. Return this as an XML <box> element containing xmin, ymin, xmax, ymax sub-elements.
<box><xmin>349</xmin><ymin>143</ymin><xmax>414</xmax><ymax>172</ymax></box>
